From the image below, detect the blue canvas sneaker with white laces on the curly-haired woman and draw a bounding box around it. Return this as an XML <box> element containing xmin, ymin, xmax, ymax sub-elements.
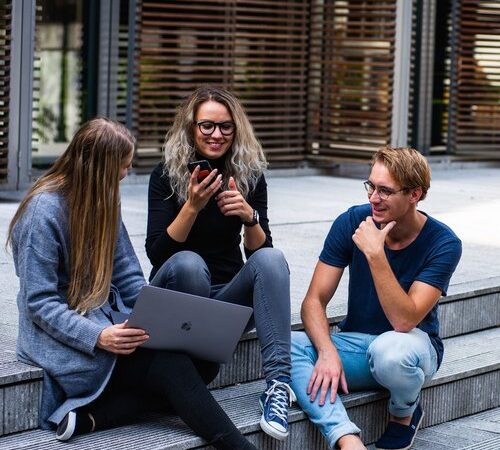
<box><xmin>259</xmin><ymin>380</ymin><xmax>297</xmax><ymax>441</ymax></box>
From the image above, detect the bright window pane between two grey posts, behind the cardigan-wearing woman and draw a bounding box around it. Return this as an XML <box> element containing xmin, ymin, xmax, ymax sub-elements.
<box><xmin>33</xmin><ymin>0</ymin><xmax>83</xmax><ymax>166</ymax></box>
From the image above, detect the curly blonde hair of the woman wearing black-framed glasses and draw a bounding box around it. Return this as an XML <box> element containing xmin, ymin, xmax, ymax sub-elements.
<box><xmin>163</xmin><ymin>86</ymin><xmax>267</xmax><ymax>204</ymax></box>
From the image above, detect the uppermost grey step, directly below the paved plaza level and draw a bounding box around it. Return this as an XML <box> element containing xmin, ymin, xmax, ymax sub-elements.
<box><xmin>0</xmin><ymin>277</ymin><xmax>500</xmax><ymax>436</ymax></box>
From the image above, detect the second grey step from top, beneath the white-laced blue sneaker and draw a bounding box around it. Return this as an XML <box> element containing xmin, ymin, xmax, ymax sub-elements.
<box><xmin>0</xmin><ymin>328</ymin><xmax>500</xmax><ymax>450</ymax></box>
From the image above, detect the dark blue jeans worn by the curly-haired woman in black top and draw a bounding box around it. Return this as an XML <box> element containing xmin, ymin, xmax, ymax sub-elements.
<box><xmin>151</xmin><ymin>248</ymin><xmax>291</xmax><ymax>382</ymax></box>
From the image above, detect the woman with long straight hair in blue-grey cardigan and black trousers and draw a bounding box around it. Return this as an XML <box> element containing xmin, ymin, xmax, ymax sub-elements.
<box><xmin>8</xmin><ymin>118</ymin><xmax>255</xmax><ymax>450</ymax></box>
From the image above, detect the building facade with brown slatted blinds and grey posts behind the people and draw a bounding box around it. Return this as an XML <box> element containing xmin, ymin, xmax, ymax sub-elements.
<box><xmin>0</xmin><ymin>0</ymin><xmax>500</xmax><ymax>189</ymax></box>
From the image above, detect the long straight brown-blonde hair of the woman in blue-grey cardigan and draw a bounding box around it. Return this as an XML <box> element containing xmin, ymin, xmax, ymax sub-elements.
<box><xmin>7</xmin><ymin>118</ymin><xmax>135</xmax><ymax>314</ymax></box>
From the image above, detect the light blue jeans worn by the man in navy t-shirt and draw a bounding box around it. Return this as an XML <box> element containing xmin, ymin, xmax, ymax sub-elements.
<box><xmin>291</xmin><ymin>328</ymin><xmax>437</xmax><ymax>448</ymax></box>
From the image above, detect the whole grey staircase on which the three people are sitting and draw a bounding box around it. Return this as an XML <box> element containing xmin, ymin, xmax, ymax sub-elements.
<box><xmin>0</xmin><ymin>277</ymin><xmax>500</xmax><ymax>450</ymax></box>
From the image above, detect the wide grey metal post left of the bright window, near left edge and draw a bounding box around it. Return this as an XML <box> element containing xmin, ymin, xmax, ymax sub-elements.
<box><xmin>7</xmin><ymin>0</ymin><xmax>36</xmax><ymax>190</ymax></box>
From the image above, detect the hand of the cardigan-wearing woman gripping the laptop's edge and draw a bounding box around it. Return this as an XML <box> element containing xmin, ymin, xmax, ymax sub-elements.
<box><xmin>97</xmin><ymin>321</ymin><xmax>149</xmax><ymax>355</ymax></box>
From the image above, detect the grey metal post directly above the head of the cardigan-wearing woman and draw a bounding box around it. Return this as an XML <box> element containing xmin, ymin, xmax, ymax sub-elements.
<box><xmin>97</xmin><ymin>0</ymin><xmax>120</xmax><ymax>118</ymax></box>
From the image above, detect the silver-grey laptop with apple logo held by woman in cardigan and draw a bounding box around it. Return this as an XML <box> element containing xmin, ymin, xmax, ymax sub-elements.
<box><xmin>119</xmin><ymin>286</ymin><xmax>253</xmax><ymax>362</ymax></box>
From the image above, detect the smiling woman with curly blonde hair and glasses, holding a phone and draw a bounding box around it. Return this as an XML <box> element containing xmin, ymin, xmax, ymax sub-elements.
<box><xmin>146</xmin><ymin>87</ymin><xmax>295</xmax><ymax>439</ymax></box>
